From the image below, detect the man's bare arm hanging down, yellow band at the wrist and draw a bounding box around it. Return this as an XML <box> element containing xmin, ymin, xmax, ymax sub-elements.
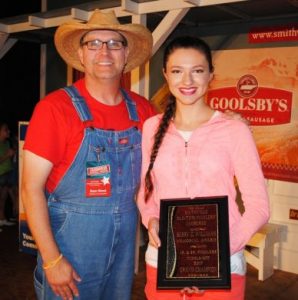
<box><xmin>21</xmin><ymin>150</ymin><xmax>80</xmax><ymax>299</ymax></box>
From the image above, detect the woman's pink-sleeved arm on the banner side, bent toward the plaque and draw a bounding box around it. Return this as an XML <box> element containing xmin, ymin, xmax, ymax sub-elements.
<box><xmin>231</xmin><ymin>124</ymin><xmax>269</xmax><ymax>253</ymax></box>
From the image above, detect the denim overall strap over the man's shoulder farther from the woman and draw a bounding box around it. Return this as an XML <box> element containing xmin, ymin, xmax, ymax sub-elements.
<box><xmin>63</xmin><ymin>85</ymin><xmax>93</xmax><ymax>122</ymax></box>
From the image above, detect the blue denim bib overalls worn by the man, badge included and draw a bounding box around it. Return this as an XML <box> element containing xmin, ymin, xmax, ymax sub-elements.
<box><xmin>35</xmin><ymin>86</ymin><xmax>141</xmax><ymax>300</ymax></box>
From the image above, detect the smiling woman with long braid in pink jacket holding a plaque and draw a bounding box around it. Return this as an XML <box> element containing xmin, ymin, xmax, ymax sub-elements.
<box><xmin>138</xmin><ymin>37</ymin><xmax>269</xmax><ymax>300</ymax></box>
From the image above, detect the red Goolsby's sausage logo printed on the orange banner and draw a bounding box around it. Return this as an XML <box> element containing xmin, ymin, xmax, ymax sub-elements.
<box><xmin>208</xmin><ymin>74</ymin><xmax>293</xmax><ymax>126</ymax></box>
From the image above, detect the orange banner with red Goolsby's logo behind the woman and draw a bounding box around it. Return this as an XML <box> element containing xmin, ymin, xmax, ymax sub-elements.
<box><xmin>207</xmin><ymin>47</ymin><xmax>298</xmax><ymax>182</ymax></box>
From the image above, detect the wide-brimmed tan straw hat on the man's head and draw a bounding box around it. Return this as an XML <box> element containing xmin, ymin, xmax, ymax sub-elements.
<box><xmin>54</xmin><ymin>9</ymin><xmax>153</xmax><ymax>72</ymax></box>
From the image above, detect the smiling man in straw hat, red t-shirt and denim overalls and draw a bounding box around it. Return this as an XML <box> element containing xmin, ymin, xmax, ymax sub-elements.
<box><xmin>22</xmin><ymin>10</ymin><xmax>155</xmax><ymax>300</ymax></box>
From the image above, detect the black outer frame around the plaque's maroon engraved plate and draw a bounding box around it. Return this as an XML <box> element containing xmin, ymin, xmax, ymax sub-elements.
<box><xmin>157</xmin><ymin>196</ymin><xmax>231</xmax><ymax>289</ymax></box>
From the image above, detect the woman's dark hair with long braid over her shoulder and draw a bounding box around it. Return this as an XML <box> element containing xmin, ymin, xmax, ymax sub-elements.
<box><xmin>145</xmin><ymin>36</ymin><xmax>214</xmax><ymax>202</ymax></box>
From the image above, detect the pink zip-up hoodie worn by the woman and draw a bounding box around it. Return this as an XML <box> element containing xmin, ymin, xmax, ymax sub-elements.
<box><xmin>137</xmin><ymin>112</ymin><xmax>269</xmax><ymax>255</ymax></box>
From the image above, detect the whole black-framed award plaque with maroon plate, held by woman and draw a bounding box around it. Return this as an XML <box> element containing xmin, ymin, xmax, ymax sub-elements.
<box><xmin>157</xmin><ymin>196</ymin><xmax>231</xmax><ymax>289</ymax></box>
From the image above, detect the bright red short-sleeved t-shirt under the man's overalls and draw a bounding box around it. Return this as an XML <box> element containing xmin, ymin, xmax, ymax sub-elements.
<box><xmin>24</xmin><ymin>79</ymin><xmax>156</xmax><ymax>191</ymax></box>
